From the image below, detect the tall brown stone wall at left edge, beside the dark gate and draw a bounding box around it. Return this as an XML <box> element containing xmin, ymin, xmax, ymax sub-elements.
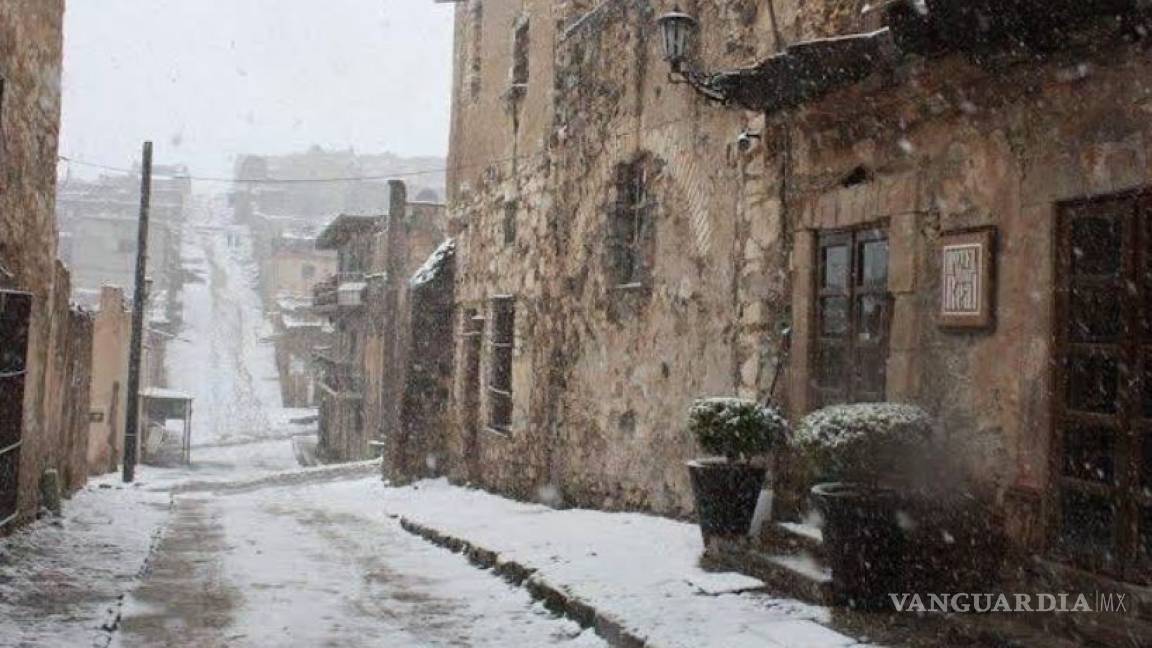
<box><xmin>0</xmin><ymin>0</ymin><xmax>68</xmax><ymax>521</ymax></box>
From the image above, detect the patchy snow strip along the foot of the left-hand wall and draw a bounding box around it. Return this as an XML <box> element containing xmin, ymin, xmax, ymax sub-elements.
<box><xmin>0</xmin><ymin>468</ymin><xmax>169</xmax><ymax>648</ymax></box>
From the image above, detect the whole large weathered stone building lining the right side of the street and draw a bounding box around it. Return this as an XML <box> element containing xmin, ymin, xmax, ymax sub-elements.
<box><xmin>435</xmin><ymin>0</ymin><xmax>1152</xmax><ymax>608</ymax></box>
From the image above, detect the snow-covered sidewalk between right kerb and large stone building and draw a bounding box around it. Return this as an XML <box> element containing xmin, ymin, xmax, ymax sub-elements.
<box><xmin>373</xmin><ymin>480</ymin><xmax>857</xmax><ymax>648</ymax></box>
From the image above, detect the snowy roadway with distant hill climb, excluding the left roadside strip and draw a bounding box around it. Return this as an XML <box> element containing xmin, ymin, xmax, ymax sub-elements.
<box><xmin>114</xmin><ymin>205</ymin><xmax>601</xmax><ymax>647</ymax></box>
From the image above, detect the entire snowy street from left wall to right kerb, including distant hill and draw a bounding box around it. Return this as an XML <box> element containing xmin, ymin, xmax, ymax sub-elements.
<box><xmin>0</xmin><ymin>205</ymin><xmax>604</xmax><ymax>647</ymax></box>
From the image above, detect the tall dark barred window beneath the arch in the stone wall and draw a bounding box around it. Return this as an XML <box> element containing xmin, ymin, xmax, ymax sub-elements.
<box><xmin>609</xmin><ymin>158</ymin><xmax>651</xmax><ymax>285</ymax></box>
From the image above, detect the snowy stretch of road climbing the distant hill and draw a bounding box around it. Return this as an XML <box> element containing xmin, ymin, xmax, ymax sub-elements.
<box><xmin>154</xmin><ymin>197</ymin><xmax>316</xmax><ymax>484</ymax></box>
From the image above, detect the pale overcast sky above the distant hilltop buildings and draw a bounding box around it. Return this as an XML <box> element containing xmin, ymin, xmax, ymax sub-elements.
<box><xmin>60</xmin><ymin>0</ymin><xmax>453</xmax><ymax>175</ymax></box>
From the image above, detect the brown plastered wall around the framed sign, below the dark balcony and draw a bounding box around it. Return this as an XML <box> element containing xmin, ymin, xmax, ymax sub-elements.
<box><xmin>789</xmin><ymin>39</ymin><xmax>1152</xmax><ymax>544</ymax></box>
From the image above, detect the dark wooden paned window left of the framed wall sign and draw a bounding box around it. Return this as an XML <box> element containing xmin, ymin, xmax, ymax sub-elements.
<box><xmin>812</xmin><ymin>229</ymin><xmax>890</xmax><ymax>407</ymax></box>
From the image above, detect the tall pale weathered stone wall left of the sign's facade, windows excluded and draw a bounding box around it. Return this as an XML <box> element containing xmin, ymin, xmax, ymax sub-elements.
<box><xmin>440</xmin><ymin>0</ymin><xmax>787</xmax><ymax>515</ymax></box>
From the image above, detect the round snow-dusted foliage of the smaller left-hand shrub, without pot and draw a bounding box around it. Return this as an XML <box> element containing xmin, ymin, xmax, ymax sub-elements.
<box><xmin>688</xmin><ymin>398</ymin><xmax>788</xmax><ymax>461</ymax></box>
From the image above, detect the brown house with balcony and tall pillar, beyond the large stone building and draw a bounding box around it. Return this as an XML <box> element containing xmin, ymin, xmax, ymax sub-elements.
<box><xmin>313</xmin><ymin>181</ymin><xmax>446</xmax><ymax>461</ymax></box>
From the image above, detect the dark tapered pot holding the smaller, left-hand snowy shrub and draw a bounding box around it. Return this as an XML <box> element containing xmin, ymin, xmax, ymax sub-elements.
<box><xmin>688</xmin><ymin>460</ymin><xmax>768</xmax><ymax>540</ymax></box>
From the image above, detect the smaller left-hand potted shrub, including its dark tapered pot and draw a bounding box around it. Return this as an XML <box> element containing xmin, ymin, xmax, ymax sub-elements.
<box><xmin>688</xmin><ymin>398</ymin><xmax>788</xmax><ymax>538</ymax></box>
